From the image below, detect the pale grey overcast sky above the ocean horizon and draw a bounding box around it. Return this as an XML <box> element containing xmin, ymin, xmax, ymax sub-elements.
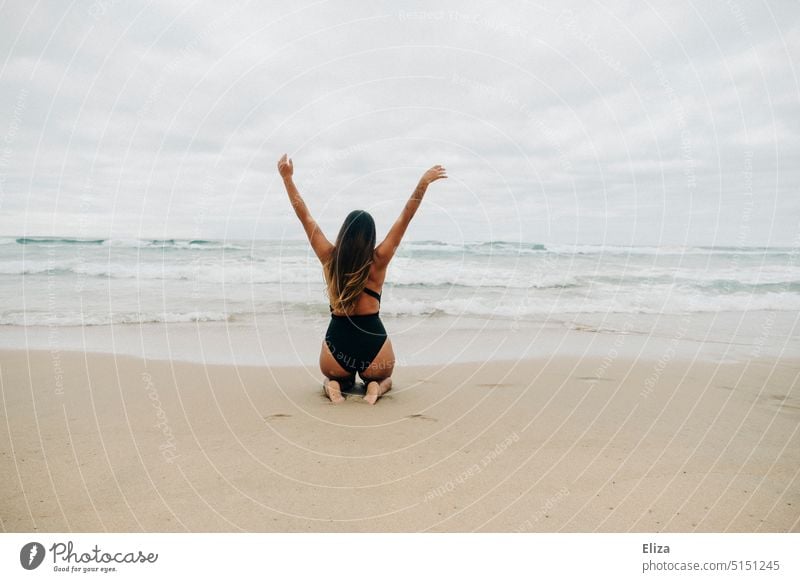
<box><xmin>0</xmin><ymin>0</ymin><xmax>800</xmax><ymax>245</ymax></box>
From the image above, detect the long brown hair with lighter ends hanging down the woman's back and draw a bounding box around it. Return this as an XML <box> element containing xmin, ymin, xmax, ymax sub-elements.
<box><xmin>324</xmin><ymin>210</ymin><xmax>375</xmax><ymax>313</ymax></box>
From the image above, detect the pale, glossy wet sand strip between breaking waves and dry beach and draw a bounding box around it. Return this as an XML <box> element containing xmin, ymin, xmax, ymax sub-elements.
<box><xmin>0</xmin><ymin>311</ymin><xmax>800</xmax><ymax>366</ymax></box>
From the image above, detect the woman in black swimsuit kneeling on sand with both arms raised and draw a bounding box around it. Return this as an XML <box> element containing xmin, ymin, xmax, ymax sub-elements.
<box><xmin>278</xmin><ymin>154</ymin><xmax>447</xmax><ymax>404</ymax></box>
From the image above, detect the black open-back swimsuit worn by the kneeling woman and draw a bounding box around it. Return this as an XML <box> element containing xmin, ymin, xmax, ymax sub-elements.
<box><xmin>325</xmin><ymin>288</ymin><xmax>387</xmax><ymax>375</ymax></box>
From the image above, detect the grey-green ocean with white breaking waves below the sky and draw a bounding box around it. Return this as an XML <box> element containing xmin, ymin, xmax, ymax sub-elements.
<box><xmin>0</xmin><ymin>237</ymin><xmax>800</xmax><ymax>327</ymax></box>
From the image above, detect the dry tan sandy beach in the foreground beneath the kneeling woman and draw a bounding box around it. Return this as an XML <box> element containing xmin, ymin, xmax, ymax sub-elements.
<box><xmin>0</xmin><ymin>350</ymin><xmax>800</xmax><ymax>532</ymax></box>
